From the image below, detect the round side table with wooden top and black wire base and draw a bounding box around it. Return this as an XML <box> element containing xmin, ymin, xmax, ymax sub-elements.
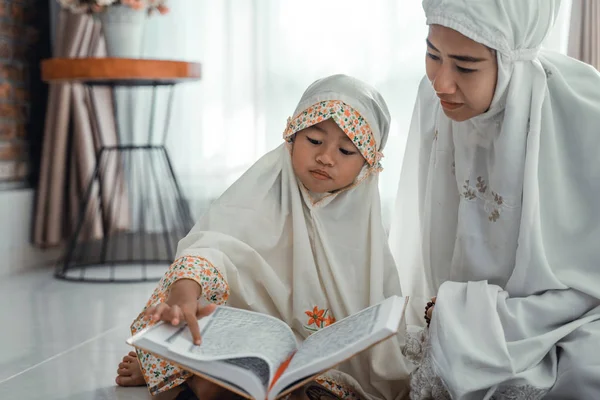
<box><xmin>42</xmin><ymin>58</ymin><xmax>200</xmax><ymax>282</ymax></box>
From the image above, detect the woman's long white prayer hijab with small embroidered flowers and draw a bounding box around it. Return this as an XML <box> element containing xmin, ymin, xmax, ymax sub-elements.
<box><xmin>390</xmin><ymin>0</ymin><xmax>600</xmax><ymax>399</ymax></box>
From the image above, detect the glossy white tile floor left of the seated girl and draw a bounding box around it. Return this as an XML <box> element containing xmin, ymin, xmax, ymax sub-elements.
<box><xmin>0</xmin><ymin>269</ymin><xmax>177</xmax><ymax>400</ymax></box>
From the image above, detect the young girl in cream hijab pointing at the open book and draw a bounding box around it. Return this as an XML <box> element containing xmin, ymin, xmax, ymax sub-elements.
<box><xmin>117</xmin><ymin>75</ymin><xmax>409</xmax><ymax>400</ymax></box>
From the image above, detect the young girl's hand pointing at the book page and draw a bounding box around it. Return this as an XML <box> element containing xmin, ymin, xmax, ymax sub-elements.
<box><xmin>145</xmin><ymin>279</ymin><xmax>216</xmax><ymax>345</ymax></box>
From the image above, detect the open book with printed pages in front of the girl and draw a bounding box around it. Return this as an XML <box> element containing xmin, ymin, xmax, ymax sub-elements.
<box><xmin>127</xmin><ymin>296</ymin><xmax>408</xmax><ymax>400</ymax></box>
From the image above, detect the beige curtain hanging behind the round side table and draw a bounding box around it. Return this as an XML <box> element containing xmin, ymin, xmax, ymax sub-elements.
<box><xmin>33</xmin><ymin>10</ymin><xmax>127</xmax><ymax>247</ymax></box>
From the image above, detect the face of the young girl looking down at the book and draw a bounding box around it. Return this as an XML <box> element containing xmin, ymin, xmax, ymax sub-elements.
<box><xmin>292</xmin><ymin>119</ymin><xmax>366</xmax><ymax>193</ymax></box>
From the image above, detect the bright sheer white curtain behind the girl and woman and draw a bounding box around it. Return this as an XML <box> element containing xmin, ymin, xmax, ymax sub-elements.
<box><xmin>139</xmin><ymin>0</ymin><xmax>570</xmax><ymax>221</ymax></box>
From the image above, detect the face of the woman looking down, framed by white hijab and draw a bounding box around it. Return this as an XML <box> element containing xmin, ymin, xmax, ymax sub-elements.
<box><xmin>425</xmin><ymin>25</ymin><xmax>498</xmax><ymax>122</ymax></box>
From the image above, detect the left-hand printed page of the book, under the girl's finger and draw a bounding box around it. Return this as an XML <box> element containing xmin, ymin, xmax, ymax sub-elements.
<box><xmin>169</xmin><ymin>306</ymin><xmax>297</xmax><ymax>387</ymax></box>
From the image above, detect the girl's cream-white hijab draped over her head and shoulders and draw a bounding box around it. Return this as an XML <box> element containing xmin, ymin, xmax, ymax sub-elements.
<box><xmin>177</xmin><ymin>75</ymin><xmax>408</xmax><ymax>399</ymax></box>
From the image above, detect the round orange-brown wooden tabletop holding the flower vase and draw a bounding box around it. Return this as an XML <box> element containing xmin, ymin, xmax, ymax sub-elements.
<box><xmin>42</xmin><ymin>58</ymin><xmax>200</xmax><ymax>85</ymax></box>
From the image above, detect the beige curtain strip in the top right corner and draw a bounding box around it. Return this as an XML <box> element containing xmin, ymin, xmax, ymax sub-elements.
<box><xmin>568</xmin><ymin>0</ymin><xmax>600</xmax><ymax>70</ymax></box>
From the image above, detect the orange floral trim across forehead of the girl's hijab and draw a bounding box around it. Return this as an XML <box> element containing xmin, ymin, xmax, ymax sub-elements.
<box><xmin>283</xmin><ymin>100</ymin><xmax>383</xmax><ymax>171</ymax></box>
